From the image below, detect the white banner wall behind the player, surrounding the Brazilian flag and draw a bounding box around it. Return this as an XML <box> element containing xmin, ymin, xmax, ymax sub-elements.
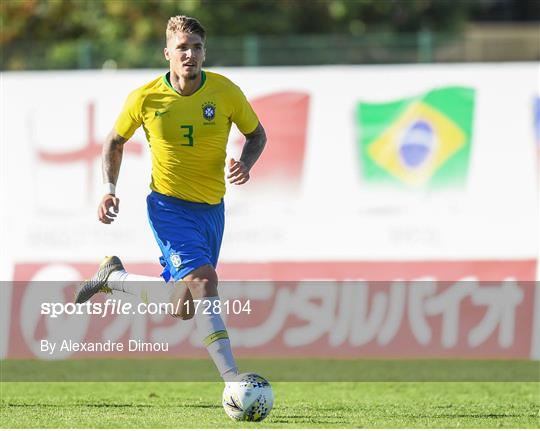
<box><xmin>0</xmin><ymin>63</ymin><xmax>540</xmax><ymax>279</ymax></box>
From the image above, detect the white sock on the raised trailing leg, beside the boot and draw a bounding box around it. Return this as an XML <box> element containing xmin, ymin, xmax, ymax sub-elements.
<box><xmin>107</xmin><ymin>271</ymin><xmax>171</xmax><ymax>303</ymax></box>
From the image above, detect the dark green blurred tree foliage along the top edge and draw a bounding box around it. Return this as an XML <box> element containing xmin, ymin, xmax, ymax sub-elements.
<box><xmin>0</xmin><ymin>0</ymin><xmax>540</xmax><ymax>69</ymax></box>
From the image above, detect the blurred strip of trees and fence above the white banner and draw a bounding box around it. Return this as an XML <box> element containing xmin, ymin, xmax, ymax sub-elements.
<box><xmin>0</xmin><ymin>0</ymin><xmax>540</xmax><ymax>70</ymax></box>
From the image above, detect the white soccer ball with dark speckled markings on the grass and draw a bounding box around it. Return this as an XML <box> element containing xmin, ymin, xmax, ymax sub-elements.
<box><xmin>223</xmin><ymin>373</ymin><xmax>274</xmax><ymax>422</ymax></box>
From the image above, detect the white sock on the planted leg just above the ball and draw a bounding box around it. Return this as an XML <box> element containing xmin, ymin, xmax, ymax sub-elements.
<box><xmin>195</xmin><ymin>296</ymin><xmax>238</xmax><ymax>382</ymax></box>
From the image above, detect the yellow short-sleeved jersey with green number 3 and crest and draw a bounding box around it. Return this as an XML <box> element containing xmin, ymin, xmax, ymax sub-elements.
<box><xmin>115</xmin><ymin>71</ymin><xmax>259</xmax><ymax>204</ymax></box>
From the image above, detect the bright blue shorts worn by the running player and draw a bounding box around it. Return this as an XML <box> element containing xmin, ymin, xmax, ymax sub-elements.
<box><xmin>146</xmin><ymin>191</ymin><xmax>225</xmax><ymax>281</ymax></box>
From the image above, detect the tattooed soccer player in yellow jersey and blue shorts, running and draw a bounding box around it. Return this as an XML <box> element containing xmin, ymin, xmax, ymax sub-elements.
<box><xmin>76</xmin><ymin>16</ymin><xmax>266</xmax><ymax>381</ymax></box>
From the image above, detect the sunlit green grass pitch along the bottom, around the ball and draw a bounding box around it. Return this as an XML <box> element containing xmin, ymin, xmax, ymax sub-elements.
<box><xmin>0</xmin><ymin>361</ymin><xmax>540</xmax><ymax>428</ymax></box>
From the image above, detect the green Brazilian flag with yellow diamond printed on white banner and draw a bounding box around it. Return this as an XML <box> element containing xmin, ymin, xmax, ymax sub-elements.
<box><xmin>356</xmin><ymin>87</ymin><xmax>475</xmax><ymax>188</ymax></box>
